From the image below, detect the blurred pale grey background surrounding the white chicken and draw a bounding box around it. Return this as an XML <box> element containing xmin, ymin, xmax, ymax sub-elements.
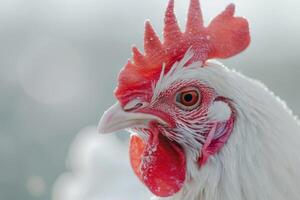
<box><xmin>0</xmin><ymin>0</ymin><xmax>300</xmax><ymax>200</ymax></box>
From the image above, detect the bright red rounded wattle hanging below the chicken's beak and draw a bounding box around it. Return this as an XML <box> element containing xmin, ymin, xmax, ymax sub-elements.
<box><xmin>130</xmin><ymin>134</ymin><xmax>186</xmax><ymax>197</ymax></box>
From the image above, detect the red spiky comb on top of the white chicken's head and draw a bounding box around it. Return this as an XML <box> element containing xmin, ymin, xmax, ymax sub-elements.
<box><xmin>116</xmin><ymin>0</ymin><xmax>250</xmax><ymax>103</ymax></box>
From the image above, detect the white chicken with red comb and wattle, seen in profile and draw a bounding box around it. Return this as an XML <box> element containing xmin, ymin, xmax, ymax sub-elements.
<box><xmin>98</xmin><ymin>0</ymin><xmax>300</xmax><ymax>200</ymax></box>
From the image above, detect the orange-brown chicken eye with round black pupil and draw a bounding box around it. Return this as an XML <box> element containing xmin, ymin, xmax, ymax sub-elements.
<box><xmin>176</xmin><ymin>88</ymin><xmax>200</xmax><ymax>110</ymax></box>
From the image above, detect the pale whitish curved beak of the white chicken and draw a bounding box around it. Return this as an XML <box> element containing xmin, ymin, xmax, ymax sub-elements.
<box><xmin>98</xmin><ymin>103</ymin><xmax>167</xmax><ymax>133</ymax></box>
